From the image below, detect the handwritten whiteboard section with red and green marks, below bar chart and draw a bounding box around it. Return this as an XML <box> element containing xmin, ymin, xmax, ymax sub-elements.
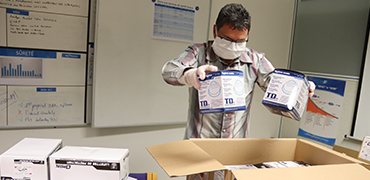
<box><xmin>7</xmin><ymin>86</ymin><xmax>85</xmax><ymax>127</ymax></box>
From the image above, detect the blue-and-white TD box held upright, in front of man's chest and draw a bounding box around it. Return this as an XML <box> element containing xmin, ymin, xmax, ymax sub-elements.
<box><xmin>198</xmin><ymin>70</ymin><xmax>246</xmax><ymax>114</ymax></box>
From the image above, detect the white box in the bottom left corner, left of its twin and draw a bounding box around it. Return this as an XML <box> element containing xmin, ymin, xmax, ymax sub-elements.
<box><xmin>0</xmin><ymin>138</ymin><xmax>62</xmax><ymax>180</ymax></box>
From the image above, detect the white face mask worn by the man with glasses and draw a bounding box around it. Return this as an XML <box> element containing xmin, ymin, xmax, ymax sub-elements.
<box><xmin>212</xmin><ymin>36</ymin><xmax>247</xmax><ymax>59</ymax></box>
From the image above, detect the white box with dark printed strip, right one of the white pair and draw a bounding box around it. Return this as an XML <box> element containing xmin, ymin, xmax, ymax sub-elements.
<box><xmin>50</xmin><ymin>146</ymin><xmax>129</xmax><ymax>180</ymax></box>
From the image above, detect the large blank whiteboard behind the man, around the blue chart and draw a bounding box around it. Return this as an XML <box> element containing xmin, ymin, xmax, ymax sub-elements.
<box><xmin>92</xmin><ymin>0</ymin><xmax>210</xmax><ymax>127</ymax></box>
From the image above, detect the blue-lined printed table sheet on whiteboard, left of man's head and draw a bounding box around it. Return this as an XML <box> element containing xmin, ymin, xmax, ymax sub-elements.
<box><xmin>152</xmin><ymin>0</ymin><xmax>199</xmax><ymax>42</ymax></box>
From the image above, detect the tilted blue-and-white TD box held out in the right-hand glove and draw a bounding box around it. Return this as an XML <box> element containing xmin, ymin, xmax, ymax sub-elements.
<box><xmin>262</xmin><ymin>69</ymin><xmax>309</xmax><ymax>121</ymax></box>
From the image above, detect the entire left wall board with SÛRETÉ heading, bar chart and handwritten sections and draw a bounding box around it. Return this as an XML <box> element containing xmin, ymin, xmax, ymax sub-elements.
<box><xmin>0</xmin><ymin>0</ymin><xmax>90</xmax><ymax>128</ymax></box>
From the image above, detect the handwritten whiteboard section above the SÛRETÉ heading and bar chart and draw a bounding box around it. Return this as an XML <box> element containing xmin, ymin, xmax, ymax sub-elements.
<box><xmin>7</xmin><ymin>9</ymin><xmax>88</xmax><ymax>51</ymax></box>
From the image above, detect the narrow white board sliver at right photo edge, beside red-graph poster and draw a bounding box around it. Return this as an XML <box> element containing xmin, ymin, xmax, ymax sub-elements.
<box><xmin>353</xmin><ymin>31</ymin><xmax>370</xmax><ymax>141</ymax></box>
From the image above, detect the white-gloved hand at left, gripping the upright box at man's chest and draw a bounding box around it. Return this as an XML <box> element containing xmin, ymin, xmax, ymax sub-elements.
<box><xmin>181</xmin><ymin>65</ymin><xmax>218</xmax><ymax>89</ymax></box>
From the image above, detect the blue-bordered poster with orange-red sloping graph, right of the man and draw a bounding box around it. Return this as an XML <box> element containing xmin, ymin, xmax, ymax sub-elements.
<box><xmin>298</xmin><ymin>76</ymin><xmax>346</xmax><ymax>146</ymax></box>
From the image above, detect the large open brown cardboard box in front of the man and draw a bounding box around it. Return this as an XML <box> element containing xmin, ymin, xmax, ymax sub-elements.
<box><xmin>147</xmin><ymin>138</ymin><xmax>370</xmax><ymax>180</ymax></box>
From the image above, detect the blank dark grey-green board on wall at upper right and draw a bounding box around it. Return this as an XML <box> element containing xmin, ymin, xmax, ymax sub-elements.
<box><xmin>290</xmin><ymin>0</ymin><xmax>369</xmax><ymax>77</ymax></box>
